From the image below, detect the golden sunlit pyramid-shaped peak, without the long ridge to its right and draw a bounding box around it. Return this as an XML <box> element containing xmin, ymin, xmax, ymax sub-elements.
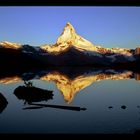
<box><xmin>41</xmin><ymin>22</ymin><xmax>97</xmax><ymax>53</ymax></box>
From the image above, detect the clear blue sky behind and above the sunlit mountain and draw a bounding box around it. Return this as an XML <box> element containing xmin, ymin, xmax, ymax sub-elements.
<box><xmin>0</xmin><ymin>6</ymin><xmax>140</xmax><ymax>48</ymax></box>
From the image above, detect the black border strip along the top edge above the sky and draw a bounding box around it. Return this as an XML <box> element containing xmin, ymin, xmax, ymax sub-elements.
<box><xmin>0</xmin><ymin>0</ymin><xmax>140</xmax><ymax>6</ymax></box>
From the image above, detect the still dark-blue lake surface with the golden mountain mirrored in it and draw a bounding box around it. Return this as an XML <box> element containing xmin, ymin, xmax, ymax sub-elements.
<box><xmin>0</xmin><ymin>68</ymin><xmax>140</xmax><ymax>134</ymax></box>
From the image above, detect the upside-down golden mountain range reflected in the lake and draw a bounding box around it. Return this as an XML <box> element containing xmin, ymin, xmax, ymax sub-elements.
<box><xmin>0</xmin><ymin>68</ymin><xmax>140</xmax><ymax>103</ymax></box>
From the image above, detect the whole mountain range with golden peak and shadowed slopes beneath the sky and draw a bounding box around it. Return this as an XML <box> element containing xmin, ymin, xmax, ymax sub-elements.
<box><xmin>0</xmin><ymin>22</ymin><xmax>140</xmax><ymax>66</ymax></box>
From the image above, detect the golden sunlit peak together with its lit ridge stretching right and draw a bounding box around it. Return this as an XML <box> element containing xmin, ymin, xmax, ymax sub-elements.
<box><xmin>41</xmin><ymin>22</ymin><xmax>134</xmax><ymax>56</ymax></box>
